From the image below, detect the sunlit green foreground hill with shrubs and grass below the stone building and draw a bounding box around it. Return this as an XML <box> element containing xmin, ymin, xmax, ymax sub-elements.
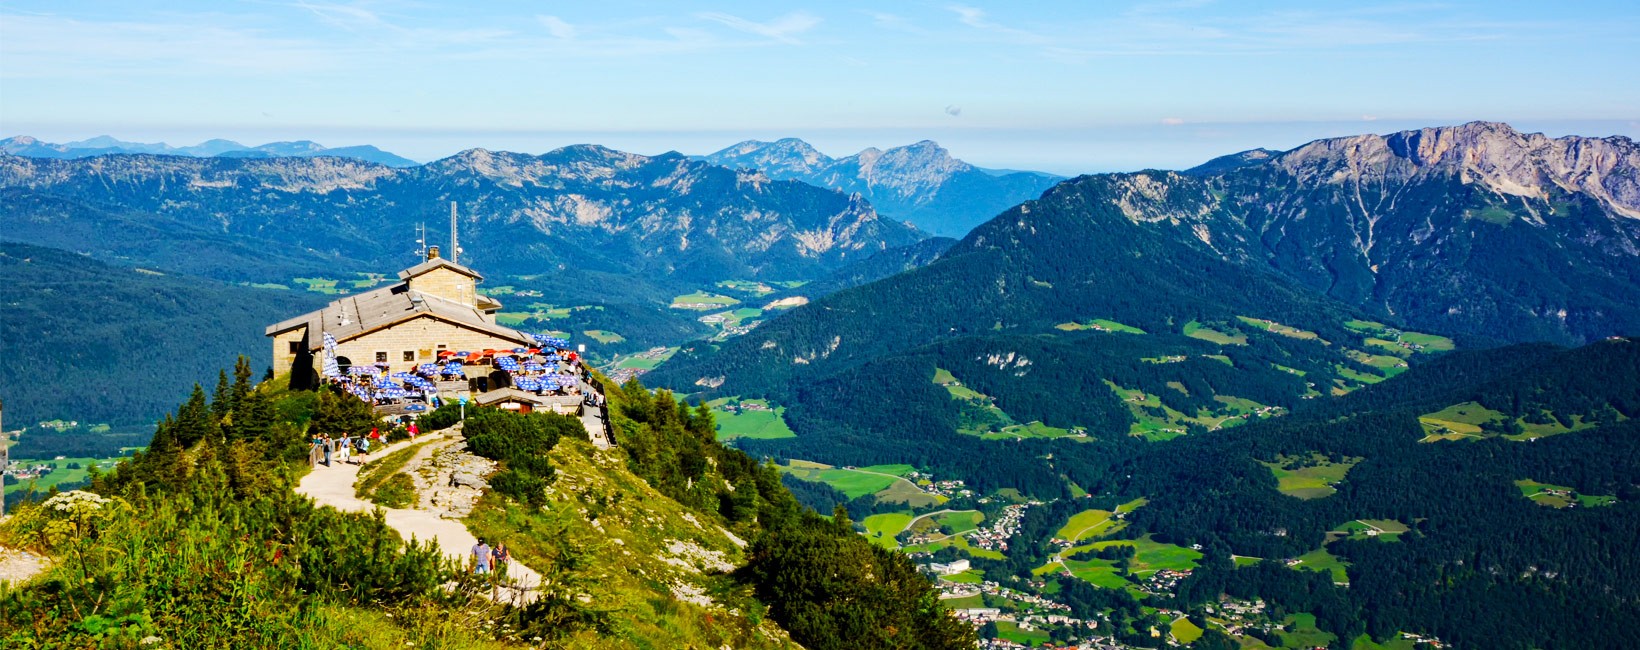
<box><xmin>0</xmin><ymin>361</ymin><xmax>973</xmax><ymax>650</ymax></box>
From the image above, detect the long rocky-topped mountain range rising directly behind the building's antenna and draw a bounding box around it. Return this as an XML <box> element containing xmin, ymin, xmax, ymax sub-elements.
<box><xmin>0</xmin><ymin>144</ymin><xmax>922</xmax><ymax>282</ymax></box>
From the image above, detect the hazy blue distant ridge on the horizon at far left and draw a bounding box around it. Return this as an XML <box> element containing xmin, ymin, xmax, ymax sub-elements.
<box><xmin>0</xmin><ymin>136</ymin><xmax>421</xmax><ymax>167</ymax></box>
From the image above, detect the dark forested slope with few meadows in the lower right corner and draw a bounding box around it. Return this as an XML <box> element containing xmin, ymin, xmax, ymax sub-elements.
<box><xmin>1102</xmin><ymin>340</ymin><xmax>1640</xmax><ymax>648</ymax></box>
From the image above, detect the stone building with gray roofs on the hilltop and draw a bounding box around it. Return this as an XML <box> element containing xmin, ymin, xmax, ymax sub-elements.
<box><xmin>266</xmin><ymin>246</ymin><xmax>536</xmax><ymax>392</ymax></box>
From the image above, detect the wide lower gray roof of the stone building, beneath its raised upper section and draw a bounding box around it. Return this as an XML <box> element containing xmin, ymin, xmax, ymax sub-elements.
<box><xmin>266</xmin><ymin>282</ymin><xmax>535</xmax><ymax>350</ymax></box>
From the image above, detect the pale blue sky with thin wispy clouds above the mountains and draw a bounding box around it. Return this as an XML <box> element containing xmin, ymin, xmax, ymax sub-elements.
<box><xmin>0</xmin><ymin>0</ymin><xmax>1640</xmax><ymax>174</ymax></box>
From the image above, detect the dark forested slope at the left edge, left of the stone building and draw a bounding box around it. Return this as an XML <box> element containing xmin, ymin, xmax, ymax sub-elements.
<box><xmin>0</xmin><ymin>243</ymin><xmax>323</xmax><ymax>427</ymax></box>
